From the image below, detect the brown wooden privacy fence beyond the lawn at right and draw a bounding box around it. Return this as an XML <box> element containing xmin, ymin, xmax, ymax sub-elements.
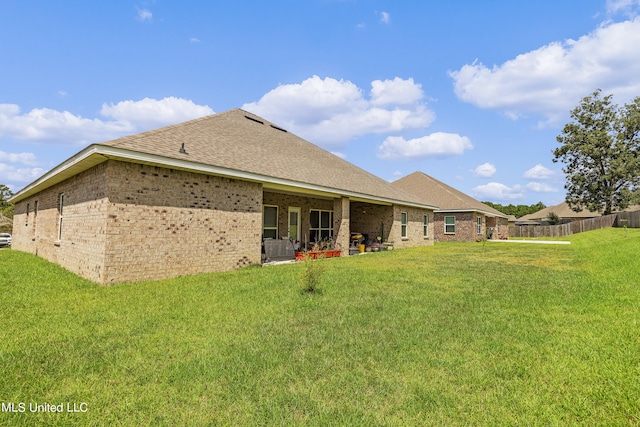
<box><xmin>509</xmin><ymin>211</ymin><xmax>616</xmax><ymax>238</ymax></box>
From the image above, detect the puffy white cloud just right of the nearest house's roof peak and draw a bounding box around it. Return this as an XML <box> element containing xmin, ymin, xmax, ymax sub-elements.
<box><xmin>242</xmin><ymin>76</ymin><xmax>435</xmax><ymax>146</ymax></box>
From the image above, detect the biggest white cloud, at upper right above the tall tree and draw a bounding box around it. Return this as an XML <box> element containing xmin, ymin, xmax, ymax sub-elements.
<box><xmin>449</xmin><ymin>18</ymin><xmax>640</xmax><ymax>123</ymax></box>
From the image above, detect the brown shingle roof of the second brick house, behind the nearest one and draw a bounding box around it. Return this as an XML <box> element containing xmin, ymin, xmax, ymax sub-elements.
<box><xmin>392</xmin><ymin>171</ymin><xmax>508</xmax><ymax>218</ymax></box>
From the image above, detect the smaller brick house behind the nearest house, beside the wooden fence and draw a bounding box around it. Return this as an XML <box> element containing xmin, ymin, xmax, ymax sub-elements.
<box><xmin>392</xmin><ymin>172</ymin><xmax>509</xmax><ymax>242</ymax></box>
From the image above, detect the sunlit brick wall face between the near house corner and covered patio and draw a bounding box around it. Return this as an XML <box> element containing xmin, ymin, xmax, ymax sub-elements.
<box><xmin>105</xmin><ymin>162</ymin><xmax>262</xmax><ymax>283</ymax></box>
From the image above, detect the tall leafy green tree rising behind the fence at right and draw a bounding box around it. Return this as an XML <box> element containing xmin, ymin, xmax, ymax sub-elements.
<box><xmin>553</xmin><ymin>89</ymin><xmax>640</xmax><ymax>215</ymax></box>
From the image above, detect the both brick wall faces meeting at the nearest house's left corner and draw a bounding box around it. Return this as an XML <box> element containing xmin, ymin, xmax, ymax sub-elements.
<box><xmin>13</xmin><ymin>161</ymin><xmax>262</xmax><ymax>284</ymax></box>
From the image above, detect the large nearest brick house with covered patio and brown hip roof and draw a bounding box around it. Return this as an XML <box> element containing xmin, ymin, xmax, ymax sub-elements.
<box><xmin>11</xmin><ymin>109</ymin><xmax>435</xmax><ymax>284</ymax></box>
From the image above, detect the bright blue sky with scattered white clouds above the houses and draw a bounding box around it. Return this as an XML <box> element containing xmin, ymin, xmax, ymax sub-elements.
<box><xmin>0</xmin><ymin>0</ymin><xmax>640</xmax><ymax>205</ymax></box>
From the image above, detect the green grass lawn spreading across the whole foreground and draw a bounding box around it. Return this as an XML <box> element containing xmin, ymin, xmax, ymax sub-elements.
<box><xmin>0</xmin><ymin>229</ymin><xmax>640</xmax><ymax>426</ymax></box>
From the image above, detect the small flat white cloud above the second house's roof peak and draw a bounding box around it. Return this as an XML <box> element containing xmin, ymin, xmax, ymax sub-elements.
<box><xmin>378</xmin><ymin>132</ymin><xmax>473</xmax><ymax>159</ymax></box>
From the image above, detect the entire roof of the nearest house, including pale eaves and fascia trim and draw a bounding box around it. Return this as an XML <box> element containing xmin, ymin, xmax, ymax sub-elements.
<box><xmin>12</xmin><ymin>109</ymin><xmax>434</xmax><ymax>208</ymax></box>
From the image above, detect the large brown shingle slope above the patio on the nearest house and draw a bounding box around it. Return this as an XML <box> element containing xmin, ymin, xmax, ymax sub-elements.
<box><xmin>97</xmin><ymin>109</ymin><xmax>425</xmax><ymax>205</ymax></box>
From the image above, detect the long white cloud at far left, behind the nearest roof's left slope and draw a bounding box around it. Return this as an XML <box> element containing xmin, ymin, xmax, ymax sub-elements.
<box><xmin>0</xmin><ymin>97</ymin><xmax>213</xmax><ymax>145</ymax></box>
